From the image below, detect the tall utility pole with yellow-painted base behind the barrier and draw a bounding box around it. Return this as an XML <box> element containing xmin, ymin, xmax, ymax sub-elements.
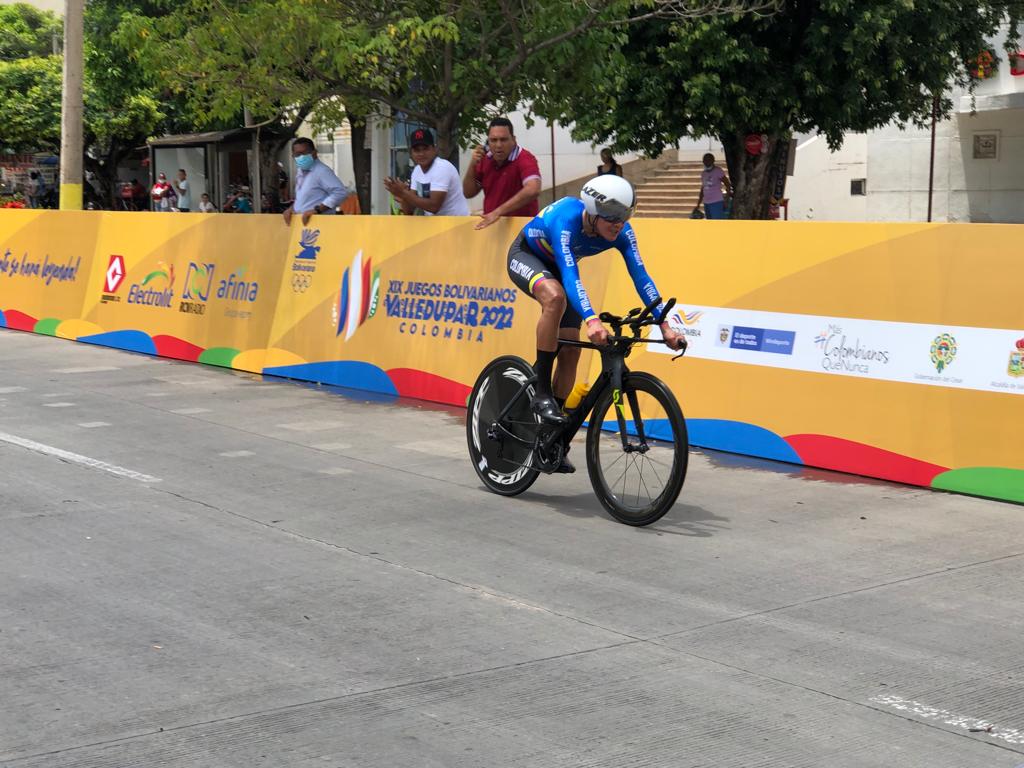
<box><xmin>60</xmin><ymin>0</ymin><xmax>85</xmax><ymax>211</ymax></box>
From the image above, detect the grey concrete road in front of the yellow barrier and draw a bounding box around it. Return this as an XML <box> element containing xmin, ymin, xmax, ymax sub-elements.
<box><xmin>6</xmin><ymin>331</ymin><xmax>1024</xmax><ymax>768</ymax></box>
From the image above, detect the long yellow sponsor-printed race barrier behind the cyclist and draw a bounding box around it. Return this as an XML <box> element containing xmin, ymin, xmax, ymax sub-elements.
<box><xmin>0</xmin><ymin>211</ymin><xmax>1024</xmax><ymax>502</ymax></box>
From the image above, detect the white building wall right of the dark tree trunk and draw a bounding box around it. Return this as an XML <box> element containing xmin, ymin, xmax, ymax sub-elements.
<box><xmin>786</xmin><ymin>27</ymin><xmax>1024</xmax><ymax>223</ymax></box>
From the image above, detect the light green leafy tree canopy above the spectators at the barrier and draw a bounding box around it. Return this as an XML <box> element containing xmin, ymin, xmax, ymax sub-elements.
<box><xmin>132</xmin><ymin>0</ymin><xmax>777</xmax><ymax>207</ymax></box>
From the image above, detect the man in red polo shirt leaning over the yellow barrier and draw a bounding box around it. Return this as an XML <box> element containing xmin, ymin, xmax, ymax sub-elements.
<box><xmin>462</xmin><ymin>118</ymin><xmax>541</xmax><ymax>229</ymax></box>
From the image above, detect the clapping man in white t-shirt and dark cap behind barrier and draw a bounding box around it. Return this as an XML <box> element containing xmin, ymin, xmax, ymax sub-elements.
<box><xmin>384</xmin><ymin>128</ymin><xmax>469</xmax><ymax>216</ymax></box>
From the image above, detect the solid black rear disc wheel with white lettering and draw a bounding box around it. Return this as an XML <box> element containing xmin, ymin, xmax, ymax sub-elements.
<box><xmin>466</xmin><ymin>355</ymin><xmax>540</xmax><ymax>496</ymax></box>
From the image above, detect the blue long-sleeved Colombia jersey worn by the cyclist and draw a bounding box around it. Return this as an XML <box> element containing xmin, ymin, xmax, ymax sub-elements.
<box><xmin>522</xmin><ymin>198</ymin><xmax>665</xmax><ymax>321</ymax></box>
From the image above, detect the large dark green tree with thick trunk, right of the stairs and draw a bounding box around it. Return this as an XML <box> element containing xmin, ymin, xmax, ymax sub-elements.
<box><xmin>542</xmin><ymin>0</ymin><xmax>1024</xmax><ymax>218</ymax></box>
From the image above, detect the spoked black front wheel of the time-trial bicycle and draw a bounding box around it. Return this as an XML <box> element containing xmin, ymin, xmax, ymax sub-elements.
<box><xmin>587</xmin><ymin>373</ymin><xmax>689</xmax><ymax>525</ymax></box>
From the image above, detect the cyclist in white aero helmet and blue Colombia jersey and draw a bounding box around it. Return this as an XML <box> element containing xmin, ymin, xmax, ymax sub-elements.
<box><xmin>508</xmin><ymin>174</ymin><xmax>686</xmax><ymax>442</ymax></box>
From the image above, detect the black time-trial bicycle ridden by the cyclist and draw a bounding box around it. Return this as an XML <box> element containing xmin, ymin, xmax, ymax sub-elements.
<box><xmin>466</xmin><ymin>298</ymin><xmax>689</xmax><ymax>525</ymax></box>
